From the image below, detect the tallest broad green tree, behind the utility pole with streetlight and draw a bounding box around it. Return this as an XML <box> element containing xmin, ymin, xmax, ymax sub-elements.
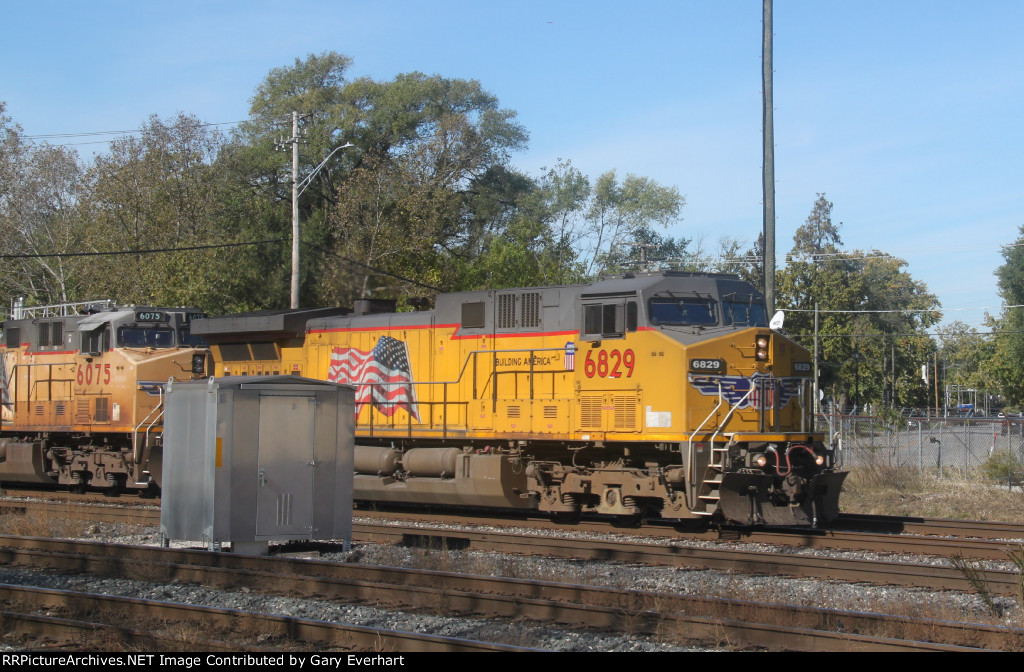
<box><xmin>236</xmin><ymin>52</ymin><xmax>526</xmax><ymax>304</ymax></box>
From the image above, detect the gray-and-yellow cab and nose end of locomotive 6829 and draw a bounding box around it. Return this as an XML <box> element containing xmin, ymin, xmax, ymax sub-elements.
<box><xmin>565</xmin><ymin>272</ymin><xmax>846</xmax><ymax>526</ymax></box>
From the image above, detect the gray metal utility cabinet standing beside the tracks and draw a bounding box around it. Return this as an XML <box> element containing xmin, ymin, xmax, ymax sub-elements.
<box><xmin>160</xmin><ymin>376</ymin><xmax>354</xmax><ymax>554</ymax></box>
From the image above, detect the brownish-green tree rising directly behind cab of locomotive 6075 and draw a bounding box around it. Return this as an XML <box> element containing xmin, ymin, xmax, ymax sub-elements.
<box><xmin>84</xmin><ymin>115</ymin><xmax>245</xmax><ymax>309</ymax></box>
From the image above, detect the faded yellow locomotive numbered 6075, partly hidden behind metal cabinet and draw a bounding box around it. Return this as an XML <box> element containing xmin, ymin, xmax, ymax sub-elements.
<box><xmin>0</xmin><ymin>301</ymin><xmax>208</xmax><ymax>494</ymax></box>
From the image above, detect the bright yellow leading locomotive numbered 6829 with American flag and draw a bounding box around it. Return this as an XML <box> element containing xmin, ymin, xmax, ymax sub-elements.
<box><xmin>195</xmin><ymin>271</ymin><xmax>846</xmax><ymax>524</ymax></box>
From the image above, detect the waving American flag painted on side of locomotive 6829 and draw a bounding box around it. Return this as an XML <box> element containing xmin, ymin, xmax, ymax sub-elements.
<box><xmin>327</xmin><ymin>336</ymin><xmax>420</xmax><ymax>421</ymax></box>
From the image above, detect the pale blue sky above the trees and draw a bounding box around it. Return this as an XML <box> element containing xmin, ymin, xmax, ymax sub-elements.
<box><xmin>0</xmin><ymin>0</ymin><xmax>1024</xmax><ymax>326</ymax></box>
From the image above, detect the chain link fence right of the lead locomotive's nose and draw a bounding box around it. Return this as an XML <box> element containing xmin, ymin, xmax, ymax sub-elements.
<box><xmin>816</xmin><ymin>414</ymin><xmax>1024</xmax><ymax>475</ymax></box>
